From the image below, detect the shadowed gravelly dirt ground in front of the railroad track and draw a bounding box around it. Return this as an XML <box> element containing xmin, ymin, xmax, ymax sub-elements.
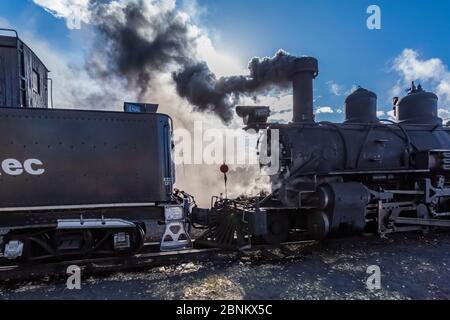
<box><xmin>0</xmin><ymin>234</ymin><xmax>450</xmax><ymax>300</ymax></box>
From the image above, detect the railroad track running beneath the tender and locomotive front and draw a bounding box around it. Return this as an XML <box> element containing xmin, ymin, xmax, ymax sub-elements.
<box><xmin>0</xmin><ymin>241</ymin><xmax>316</xmax><ymax>283</ymax></box>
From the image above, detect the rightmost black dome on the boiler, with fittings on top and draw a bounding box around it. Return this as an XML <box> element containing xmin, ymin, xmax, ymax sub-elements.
<box><xmin>395</xmin><ymin>82</ymin><xmax>442</xmax><ymax>125</ymax></box>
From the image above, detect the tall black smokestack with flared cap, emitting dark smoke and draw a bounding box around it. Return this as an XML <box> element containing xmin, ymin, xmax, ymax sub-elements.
<box><xmin>292</xmin><ymin>57</ymin><xmax>319</xmax><ymax>122</ymax></box>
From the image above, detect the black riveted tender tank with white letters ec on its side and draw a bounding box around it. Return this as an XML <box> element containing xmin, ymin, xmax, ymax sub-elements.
<box><xmin>0</xmin><ymin>108</ymin><xmax>173</xmax><ymax>208</ymax></box>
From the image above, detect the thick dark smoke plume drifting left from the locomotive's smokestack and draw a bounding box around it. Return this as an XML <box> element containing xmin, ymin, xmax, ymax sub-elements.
<box><xmin>88</xmin><ymin>0</ymin><xmax>296</xmax><ymax>122</ymax></box>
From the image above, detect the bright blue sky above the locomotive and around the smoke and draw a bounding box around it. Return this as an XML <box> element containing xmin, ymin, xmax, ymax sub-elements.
<box><xmin>0</xmin><ymin>0</ymin><xmax>450</xmax><ymax>120</ymax></box>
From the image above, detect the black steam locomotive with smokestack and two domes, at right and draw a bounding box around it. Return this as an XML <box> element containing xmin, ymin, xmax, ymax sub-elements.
<box><xmin>194</xmin><ymin>57</ymin><xmax>450</xmax><ymax>246</ymax></box>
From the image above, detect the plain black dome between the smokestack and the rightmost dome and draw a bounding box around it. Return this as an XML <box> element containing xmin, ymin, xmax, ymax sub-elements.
<box><xmin>345</xmin><ymin>87</ymin><xmax>379</xmax><ymax>123</ymax></box>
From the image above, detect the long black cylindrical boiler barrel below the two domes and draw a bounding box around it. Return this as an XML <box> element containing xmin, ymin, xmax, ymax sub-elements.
<box><xmin>279</xmin><ymin>124</ymin><xmax>450</xmax><ymax>174</ymax></box>
